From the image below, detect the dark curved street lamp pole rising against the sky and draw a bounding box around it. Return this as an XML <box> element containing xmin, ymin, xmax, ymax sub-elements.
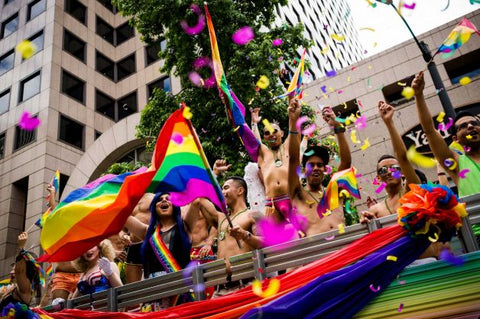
<box><xmin>375</xmin><ymin>0</ymin><xmax>455</xmax><ymax>119</ymax></box>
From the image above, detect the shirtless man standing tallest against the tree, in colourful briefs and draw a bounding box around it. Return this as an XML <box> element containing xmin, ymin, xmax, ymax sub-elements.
<box><xmin>252</xmin><ymin>104</ymin><xmax>300</xmax><ymax>222</ymax></box>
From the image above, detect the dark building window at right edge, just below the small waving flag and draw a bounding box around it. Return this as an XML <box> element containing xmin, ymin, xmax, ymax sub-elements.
<box><xmin>443</xmin><ymin>49</ymin><xmax>480</xmax><ymax>84</ymax></box>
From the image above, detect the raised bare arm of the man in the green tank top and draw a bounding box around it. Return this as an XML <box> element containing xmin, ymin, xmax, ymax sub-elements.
<box><xmin>412</xmin><ymin>72</ymin><xmax>458</xmax><ymax>184</ymax></box>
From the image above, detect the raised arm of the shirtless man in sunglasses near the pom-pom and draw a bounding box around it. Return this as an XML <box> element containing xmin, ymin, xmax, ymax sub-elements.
<box><xmin>378</xmin><ymin>101</ymin><xmax>420</xmax><ymax>190</ymax></box>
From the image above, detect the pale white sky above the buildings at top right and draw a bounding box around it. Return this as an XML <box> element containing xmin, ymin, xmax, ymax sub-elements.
<box><xmin>346</xmin><ymin>0</ymin><xmax>480</xmax><ymax>57</ymax></box>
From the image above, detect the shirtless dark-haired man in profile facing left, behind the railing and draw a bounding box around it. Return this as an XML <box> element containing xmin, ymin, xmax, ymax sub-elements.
<box><xmin>194</xmin><ymin>176</ymin><xmax>262</xmax><ymax>295</ymax></box>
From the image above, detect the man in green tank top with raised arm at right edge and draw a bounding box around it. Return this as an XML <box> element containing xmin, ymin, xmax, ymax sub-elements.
<box><xmin>412</xmin><ymin>72</ymin><xmax>480</xmax><ymax>197</ymax></box>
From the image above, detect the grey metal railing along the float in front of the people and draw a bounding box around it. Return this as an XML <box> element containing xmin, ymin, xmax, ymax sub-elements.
<box><xmin>67</xmin><ymin>194</ymin><xmax>480</xmax><ymax>311</ymax></box>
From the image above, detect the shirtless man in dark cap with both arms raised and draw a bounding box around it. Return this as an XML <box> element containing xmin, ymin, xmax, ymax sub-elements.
<box><xmin>288</xmin><ymin>100</ymin><xmax>351</xmax><ymax>236</ymax></box>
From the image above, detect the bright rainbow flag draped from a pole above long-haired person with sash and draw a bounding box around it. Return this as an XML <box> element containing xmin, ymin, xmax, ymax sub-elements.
<box><xmin>147</xmin><ymin>104</ymin><xmax>227</xmax><ymax>212</ymax></box>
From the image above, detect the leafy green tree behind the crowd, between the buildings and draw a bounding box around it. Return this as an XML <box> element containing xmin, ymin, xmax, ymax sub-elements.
<box><xmin>113</xmin><ymin>0</ymin><xmax>311</xmax><ymax>175</ymax></box>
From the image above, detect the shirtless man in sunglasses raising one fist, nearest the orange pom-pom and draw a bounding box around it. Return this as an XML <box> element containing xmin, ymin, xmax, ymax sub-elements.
<box><xmin>360</xmin><ymin>101</ymin><xmax>420</xmax><ymax>223</ymax></box>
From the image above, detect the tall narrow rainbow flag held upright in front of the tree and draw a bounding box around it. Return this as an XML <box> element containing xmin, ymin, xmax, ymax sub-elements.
<box><xmin>204</xmin><ymin>3</ymin><xmax>260</xmax><ymax>162</ymax></box>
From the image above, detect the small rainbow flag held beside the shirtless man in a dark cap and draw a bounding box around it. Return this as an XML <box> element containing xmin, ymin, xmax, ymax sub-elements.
<box><xmin>317</xmin><ymin>167</ymin><xmax>360</xmax><ymax>217</ymax></box>
